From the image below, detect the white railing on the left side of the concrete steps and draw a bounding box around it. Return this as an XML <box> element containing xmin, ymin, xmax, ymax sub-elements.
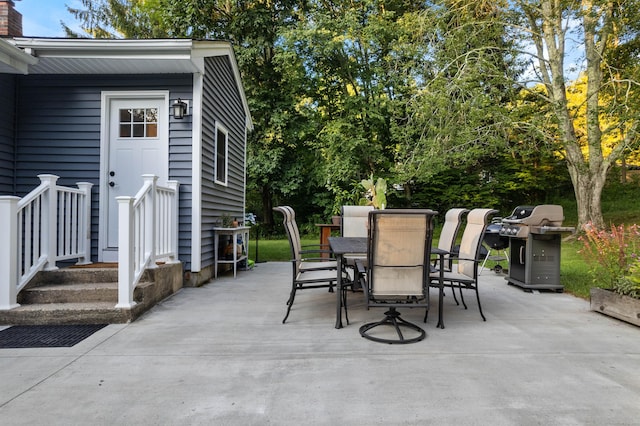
<box><xmin>0</xmin><ymin>174</ymin><xmax>93</xmax><ymax>310</ymax></box>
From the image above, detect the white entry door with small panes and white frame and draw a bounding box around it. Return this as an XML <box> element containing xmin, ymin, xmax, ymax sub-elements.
<box><xmin>100</xmin><ymin>95</ymin><xmax>169</xmax><ymax>262</ymax></box>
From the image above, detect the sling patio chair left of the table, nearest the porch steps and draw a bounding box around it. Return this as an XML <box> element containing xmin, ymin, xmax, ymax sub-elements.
<box><xmin>273</xmin><ymin>206</ymin><xmax>352</xmax><ymax>324</ymax></box>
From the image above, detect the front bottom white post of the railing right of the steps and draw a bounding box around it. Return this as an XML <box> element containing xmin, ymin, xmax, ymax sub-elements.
<box><xmin>116</xmin><ymin>197</ymin><xmax>135</xmax><ymax>308</ymax></box>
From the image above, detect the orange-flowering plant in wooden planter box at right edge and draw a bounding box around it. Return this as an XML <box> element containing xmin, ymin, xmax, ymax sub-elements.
<box><xmin>580</xmin><ymin>224</ymin><xmax>640</xmax><ymax>326</ymax></box>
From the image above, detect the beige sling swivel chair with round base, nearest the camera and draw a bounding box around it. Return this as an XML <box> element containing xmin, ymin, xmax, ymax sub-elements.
<box><xmin>360</xmin><ymin>209</ymin><xmax>437</xmax><ymax>343</ymax></box>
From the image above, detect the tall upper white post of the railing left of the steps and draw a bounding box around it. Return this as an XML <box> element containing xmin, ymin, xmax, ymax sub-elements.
<box><xmin>38</xmin><ymin>174</ymin><xmax>58</xmax><ymax>271</ymax></box>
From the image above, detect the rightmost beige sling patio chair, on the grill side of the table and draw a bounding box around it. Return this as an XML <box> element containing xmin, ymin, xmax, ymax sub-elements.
<box><xmin>430</xmin><ymin>209</ymin><xmax>498</xmax><ymax>328</ymax></box>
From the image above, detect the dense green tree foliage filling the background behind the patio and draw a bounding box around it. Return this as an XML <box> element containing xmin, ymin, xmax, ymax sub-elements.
<box><xmin>61</xmin><ymin>0</ymin><xmax>640</xmax><ymax>233</ymax></box>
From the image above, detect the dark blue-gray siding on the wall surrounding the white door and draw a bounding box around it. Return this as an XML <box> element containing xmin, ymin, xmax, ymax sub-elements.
<box><xmin>14</xmin><ymin>74</ymin><xmax>192</xmax><ymax>268</ymax></box>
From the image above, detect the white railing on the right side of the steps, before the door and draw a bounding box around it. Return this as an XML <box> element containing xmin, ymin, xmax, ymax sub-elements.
<box><xmin>116</xmin><ymin>175</ymin><xmax>178</xmax><ymax>308</ymax></box>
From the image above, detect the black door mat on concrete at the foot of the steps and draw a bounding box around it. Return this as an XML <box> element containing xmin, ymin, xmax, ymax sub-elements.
<box><xmin>0</xmin><ymin>324</ymin><xmax>107</xmax><ymax>349</ymax></box>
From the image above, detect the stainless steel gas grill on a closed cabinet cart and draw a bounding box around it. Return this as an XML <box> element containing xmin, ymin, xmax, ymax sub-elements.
<box><xmin>500</xmin><ymin>204</ymin><xmax>575</xmax><ymax>291</ymax></box>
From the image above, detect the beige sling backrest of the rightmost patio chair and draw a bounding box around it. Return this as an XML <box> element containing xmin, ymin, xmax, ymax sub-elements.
<box><xmin>458</xmin><ymin>209</ymin><xmax>498</xmax><ymax>279</ymax></box>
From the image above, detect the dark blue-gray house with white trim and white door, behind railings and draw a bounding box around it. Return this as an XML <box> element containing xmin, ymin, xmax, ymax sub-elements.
<box><xmin>0</xmin><ymin>30</ymin><xmax>252</xmax><ymax>286</ymax></box>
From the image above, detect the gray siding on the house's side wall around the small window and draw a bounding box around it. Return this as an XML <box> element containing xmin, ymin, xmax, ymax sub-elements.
<box><xmin>201</xmin><ymin>56</ymin><xmax>247</xmax><ymax>267</ymax></box>
